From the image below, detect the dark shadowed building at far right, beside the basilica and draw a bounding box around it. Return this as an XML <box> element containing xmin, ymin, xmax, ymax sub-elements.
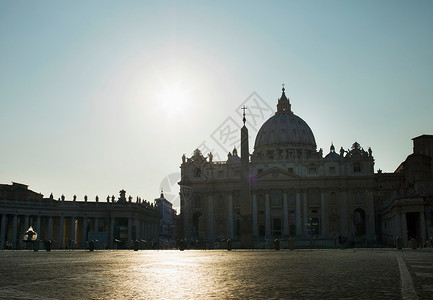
<box><xmin>376</xmin><ymin>135</ymin><xmax>433</xmax><ymax>246</ymax></box>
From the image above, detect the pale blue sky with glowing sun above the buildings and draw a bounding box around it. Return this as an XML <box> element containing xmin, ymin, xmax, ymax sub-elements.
<box><xmin>0</xmin><ymin>0</ymin><xmax>433</xmax><ymax>208</ymax></box>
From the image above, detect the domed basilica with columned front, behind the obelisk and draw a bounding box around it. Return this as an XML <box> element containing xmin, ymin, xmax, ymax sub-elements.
<box><xmin>179</xmin><ymin>88</ymin><xmax>376</xmax><ymax>248</ymax></box>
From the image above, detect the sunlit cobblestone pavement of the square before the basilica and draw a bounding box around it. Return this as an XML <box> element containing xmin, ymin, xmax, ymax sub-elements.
<box><xmin>0</xmin><ymin>249</ymin><xmax>433</xmax><ymax>299</ymax></box>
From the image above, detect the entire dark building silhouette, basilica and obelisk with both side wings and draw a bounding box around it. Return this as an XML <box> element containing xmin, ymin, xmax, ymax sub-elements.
<box><xmin>0</xmin><ymin>88</ymin><xmax>433</xmax><ymax>249</ymax></box>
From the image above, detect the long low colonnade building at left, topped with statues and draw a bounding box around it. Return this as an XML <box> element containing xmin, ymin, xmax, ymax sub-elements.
<box><xmin>0</xmin><ymin>183</ymin><xmax>161</xmax><ymax>249</ymax></box>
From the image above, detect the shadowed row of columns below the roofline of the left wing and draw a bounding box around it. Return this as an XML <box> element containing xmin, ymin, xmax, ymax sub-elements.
<box><xmin>0</xmin><ymin>213</ymin><xmax>159</xmax><ymax>249</ymax></box>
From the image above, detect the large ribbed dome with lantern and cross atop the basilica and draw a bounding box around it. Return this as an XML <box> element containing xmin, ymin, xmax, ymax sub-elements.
<box><xmin>254</xmin><ymin>88</ymin><xmax>316</xmax><ymax>152</ymax></box>
